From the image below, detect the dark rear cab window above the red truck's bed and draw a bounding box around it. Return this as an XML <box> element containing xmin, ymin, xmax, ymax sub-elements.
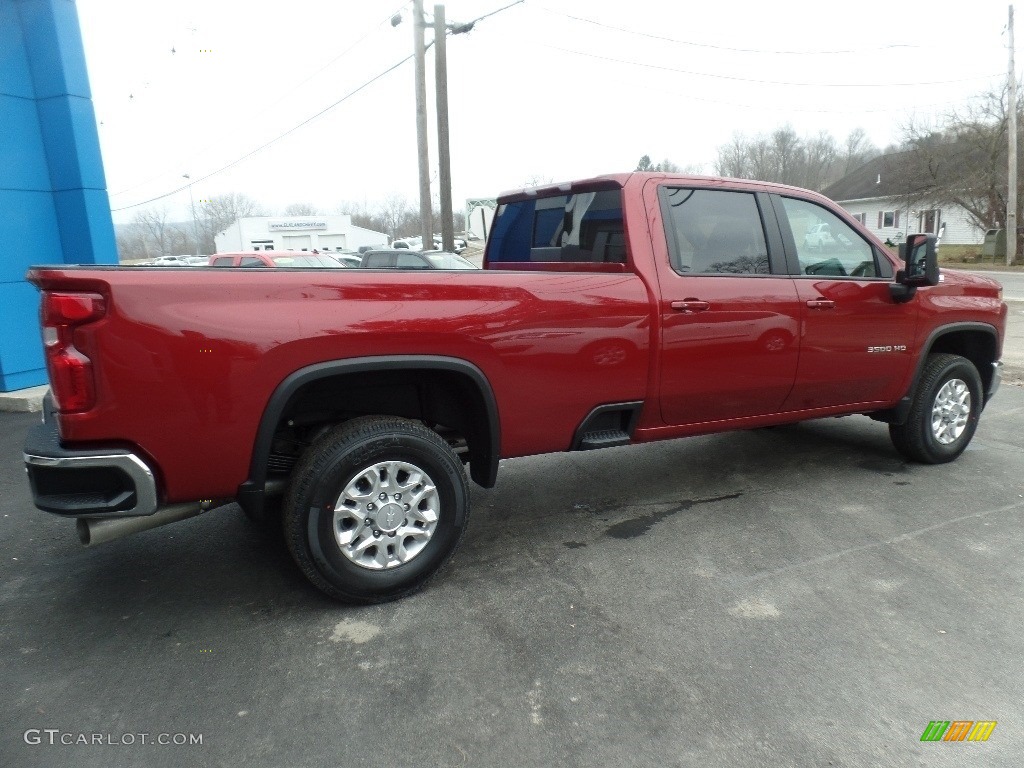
<box><xmin>487</xmin><ymin>185</ymin><xmax>628</xmax><ymax>271</ymax></box>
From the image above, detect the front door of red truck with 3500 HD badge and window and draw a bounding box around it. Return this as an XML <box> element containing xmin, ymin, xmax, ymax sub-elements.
<box><xmin>772</xmin><ymin>196</ymin><xmax>919</xmax><ymax>411</ymax></box>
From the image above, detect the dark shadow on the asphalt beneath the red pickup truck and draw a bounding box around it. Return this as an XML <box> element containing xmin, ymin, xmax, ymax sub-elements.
<box><xmin>46</xmin><ymin>419</ymin><xmax>927</xmax><ymax>635</ymax></box>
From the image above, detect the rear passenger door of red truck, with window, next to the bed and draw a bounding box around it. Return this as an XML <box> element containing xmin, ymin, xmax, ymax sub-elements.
<box><xmin>645</xmin><ymin>182</ymin><xmax>801</xmax><ymax>424</ymax></box>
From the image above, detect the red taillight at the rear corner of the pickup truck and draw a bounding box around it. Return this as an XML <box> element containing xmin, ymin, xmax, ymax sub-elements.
<box><xmin>41</xmin><ymin>293</ymin><xmax>106</xmax><ymax>412</ymax></box>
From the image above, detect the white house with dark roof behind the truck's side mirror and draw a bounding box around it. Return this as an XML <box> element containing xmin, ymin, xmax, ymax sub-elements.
<box><xmin>822</xmin><ymin>155</ymin><xmax>985</xmax><ymax>246</ymax></box>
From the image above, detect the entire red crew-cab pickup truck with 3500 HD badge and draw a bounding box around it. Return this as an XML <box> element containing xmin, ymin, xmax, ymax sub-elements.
<box><xmin>25</xmin><ymin>173</ymin><xmax>1007</xmax><ymax>602</ymax></box>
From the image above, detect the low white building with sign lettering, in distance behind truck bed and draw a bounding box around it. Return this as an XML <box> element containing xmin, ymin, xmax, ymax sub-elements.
<box><xmin>215</xmin><ymin>214</ymin><xmax>387</xmax><ymax>253</ymax></box>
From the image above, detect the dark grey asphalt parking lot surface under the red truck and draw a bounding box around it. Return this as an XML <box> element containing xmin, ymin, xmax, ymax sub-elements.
<box><xmin>0</xmin><ymin>387</ymin><xmax>1024</xmax><ymax>768</ymax></box>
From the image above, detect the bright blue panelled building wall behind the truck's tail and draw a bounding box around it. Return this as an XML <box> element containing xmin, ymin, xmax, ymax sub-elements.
<box><xmin>0</xmin><ymin>0</ymin><xmax>118</xmax><ymax>392</ymax></box>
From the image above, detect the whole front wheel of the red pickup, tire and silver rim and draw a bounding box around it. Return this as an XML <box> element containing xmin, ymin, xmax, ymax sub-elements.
<box><xmin>889</xmin><ymin>353</ymin><xmax>983</xmax><ymax>464</ymax></box>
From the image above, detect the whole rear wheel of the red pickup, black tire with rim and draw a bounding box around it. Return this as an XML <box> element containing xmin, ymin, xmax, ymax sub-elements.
<box><xmin>284</xmin><ymin>417</ymin><xmax>469</xmax><ymax>603</ymax></box>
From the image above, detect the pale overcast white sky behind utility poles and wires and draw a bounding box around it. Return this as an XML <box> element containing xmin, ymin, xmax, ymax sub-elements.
<box><xmin>78</xmin><ymin>0</ymin><xmax>1011</xmax><ymax>222</ymax></box>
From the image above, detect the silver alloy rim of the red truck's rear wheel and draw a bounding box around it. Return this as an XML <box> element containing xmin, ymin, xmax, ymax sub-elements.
<box><xmin>334</xmin><ymin>461</ymin><xmax>440</xmax><ymax>570</ymax></box>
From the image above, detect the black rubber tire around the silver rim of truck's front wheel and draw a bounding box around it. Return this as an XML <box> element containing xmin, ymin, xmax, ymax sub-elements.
<box><xmin>889</xmin><ymin>353</ymin><xmax>984</xmax><ymax>464</ymax></box>
